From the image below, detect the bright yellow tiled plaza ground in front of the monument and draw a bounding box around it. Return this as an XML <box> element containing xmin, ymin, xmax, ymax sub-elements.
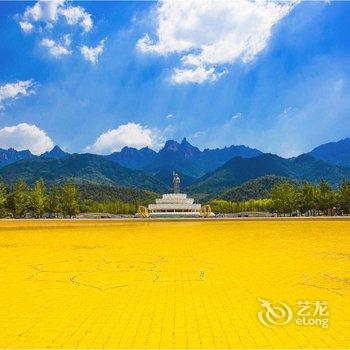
<box><xmin>0</xmin><ymin>221</ymin><xmax>350</xmax><ymax>348</ymax></box>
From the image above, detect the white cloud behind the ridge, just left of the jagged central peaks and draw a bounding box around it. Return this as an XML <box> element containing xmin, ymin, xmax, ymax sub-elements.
<box><xmin>86</xmin><ymin>123</ymin><xmax>164</xmax><ymax>154</ymax></box>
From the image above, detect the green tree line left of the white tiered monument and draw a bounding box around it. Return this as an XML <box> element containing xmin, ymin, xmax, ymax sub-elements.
<box><xmin>0</xmin><ymin>179</ymin><xmax>138</xmax><ymax>218</ymax></box>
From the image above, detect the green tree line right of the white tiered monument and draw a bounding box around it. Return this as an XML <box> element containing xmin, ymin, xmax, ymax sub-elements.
<box><xmin>210</xmin><ymin>180</ymin><xmax>350</xmax><ymax>216</ymax></box>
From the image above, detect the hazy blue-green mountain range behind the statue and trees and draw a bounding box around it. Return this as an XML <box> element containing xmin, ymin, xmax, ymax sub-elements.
<box><xmin>0</xmin><ymin>138</ymin><xmax>350</xmax><ymax>198</ymax></box>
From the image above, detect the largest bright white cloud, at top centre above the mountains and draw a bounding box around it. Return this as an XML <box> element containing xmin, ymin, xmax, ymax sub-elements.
<box><xmin>137</xmin><ymin>0</ymin><xmax>296</xmax><ymax>84</ymax></box>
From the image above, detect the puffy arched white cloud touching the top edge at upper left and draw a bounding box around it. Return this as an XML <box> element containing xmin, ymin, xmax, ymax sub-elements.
<box><xmin>19</xmin><ymin>0</ymin><xmax>93</xmax><ymax>32</ymax></box>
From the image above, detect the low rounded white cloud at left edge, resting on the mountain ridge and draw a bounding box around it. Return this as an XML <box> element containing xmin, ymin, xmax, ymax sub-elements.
<box><xmin>0</xmin><ymin>123</ymin><xmax>54</xmax><ymax>154</ymax></box>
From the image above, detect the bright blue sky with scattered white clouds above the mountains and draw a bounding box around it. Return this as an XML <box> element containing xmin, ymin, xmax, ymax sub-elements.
<box><xmin>0</xmin><ymin>0</ymin><xmax>350</xmax><ymax>156</ymax></box>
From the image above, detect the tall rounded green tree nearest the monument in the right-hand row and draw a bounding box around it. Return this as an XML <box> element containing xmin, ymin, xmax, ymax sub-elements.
<box><xmin>271</xmin><ymin>181</ymin><xmax>300</xmax><ymax>214</ymax></box>
